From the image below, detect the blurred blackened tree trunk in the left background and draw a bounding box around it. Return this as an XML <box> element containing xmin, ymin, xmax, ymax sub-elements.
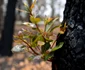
<box><xmin>0</xmin><ymin>0</ymin><xmax>17</xmax><ymax>56</ymax></box>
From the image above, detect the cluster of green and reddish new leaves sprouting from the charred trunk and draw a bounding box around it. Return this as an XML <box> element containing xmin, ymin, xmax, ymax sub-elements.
<box><xmin>12</xmin><ymin>0</ymin><xmax>67</xmax><ymax>61</ymax></box>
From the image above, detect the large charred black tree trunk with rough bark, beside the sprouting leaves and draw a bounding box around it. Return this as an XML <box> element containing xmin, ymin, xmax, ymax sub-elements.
<box><xmin>52</xmin><ymin>0</ymin><xmax>85</xmax><ymax>70</ymax></box>
